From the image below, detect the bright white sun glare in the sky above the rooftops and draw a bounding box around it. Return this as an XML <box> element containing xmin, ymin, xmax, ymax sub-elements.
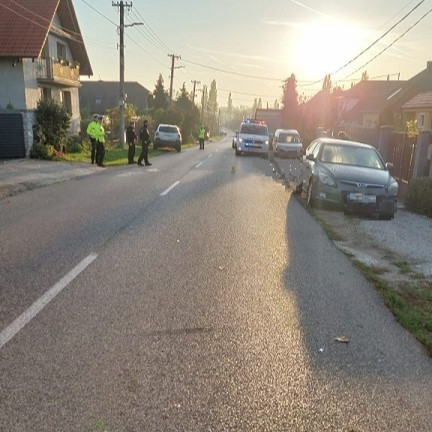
<box><xmin>295</xmin><ymin>22</ymin><xmax>366</xmax><ymax>80</ymax></box>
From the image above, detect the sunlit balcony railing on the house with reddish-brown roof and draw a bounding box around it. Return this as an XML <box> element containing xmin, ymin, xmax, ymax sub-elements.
<box><xmin>37</xmin><ymin>58</ymin><xmax>80</xmax><ymax>86</ymax></box>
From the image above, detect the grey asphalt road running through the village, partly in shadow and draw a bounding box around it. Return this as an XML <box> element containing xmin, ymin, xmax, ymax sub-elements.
<box><xmin>0</xmin><ymin>137</ymin><xmax>432</xmax><ymax>432</ymax></box>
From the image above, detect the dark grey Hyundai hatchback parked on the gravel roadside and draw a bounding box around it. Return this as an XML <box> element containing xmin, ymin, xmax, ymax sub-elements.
<box><xmin>298</xmin><ymin>138</ymin><xmax>399</xmax><ymax>219</ymax></box>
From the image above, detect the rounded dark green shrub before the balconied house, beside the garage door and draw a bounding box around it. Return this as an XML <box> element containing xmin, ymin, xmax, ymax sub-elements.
<box><xmin>35</xmin><ymin>99</ymin><xmax>70</xmax><ymax>151</ymax></box>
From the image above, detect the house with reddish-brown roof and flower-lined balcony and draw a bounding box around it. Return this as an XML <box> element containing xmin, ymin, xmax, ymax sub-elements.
<box><xmin>0</xmin><ymin>0</ymin><xmax>93</xmax><ymax>157</ymax></box>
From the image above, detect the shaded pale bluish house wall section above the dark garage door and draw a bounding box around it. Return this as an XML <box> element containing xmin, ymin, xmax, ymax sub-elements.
<box><xmin>0</xmin><ymin>59</ymin><xmax>26</xmax><ymax>110</ymax></box>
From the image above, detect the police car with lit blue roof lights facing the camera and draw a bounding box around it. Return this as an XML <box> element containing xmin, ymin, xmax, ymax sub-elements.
<box><xmin>235</xmin><ymin>119</ymin><xmax>270</xmax><ymax>157</ymax></box>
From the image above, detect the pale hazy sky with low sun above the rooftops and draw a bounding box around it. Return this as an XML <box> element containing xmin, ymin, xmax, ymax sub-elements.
<box><xmin>73</xmin><ymin>0</ymin><xmax>432</xmax><ymax>108</ymax></box>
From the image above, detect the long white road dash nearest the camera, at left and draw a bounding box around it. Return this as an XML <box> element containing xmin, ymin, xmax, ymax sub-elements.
<box><xmin>0</xmin><ymin>254</ymin><xmax>97</xmax><ymax>349</ymax></box>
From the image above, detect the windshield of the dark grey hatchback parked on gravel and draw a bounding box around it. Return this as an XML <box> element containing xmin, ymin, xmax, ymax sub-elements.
<box><xmin>320</xmin><ymin>144</ymin><xmax>384</xmax><ymax>169</ymax></box>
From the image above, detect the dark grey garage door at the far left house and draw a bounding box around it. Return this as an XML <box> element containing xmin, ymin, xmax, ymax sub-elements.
<box><xmin>0</xmin><ymin>113</ymin><xmax>25</xmax><ymax>159</ymax></box>
